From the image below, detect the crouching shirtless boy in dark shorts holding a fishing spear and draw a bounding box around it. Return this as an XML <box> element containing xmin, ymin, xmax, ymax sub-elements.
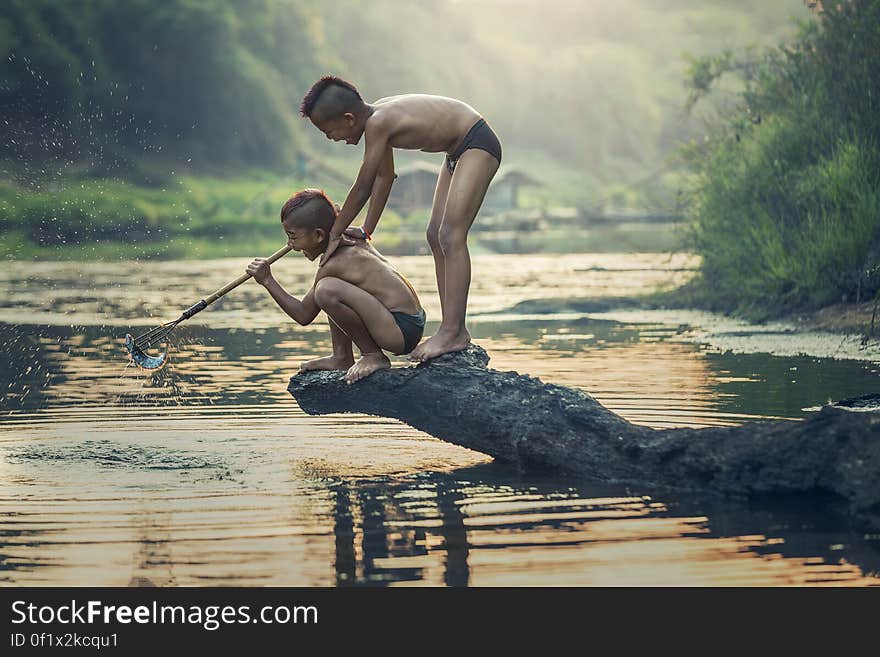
<box><xmin>247</xmin><ymin>189</ymin><xmax>425</xmax><ymax>383</ymax></box>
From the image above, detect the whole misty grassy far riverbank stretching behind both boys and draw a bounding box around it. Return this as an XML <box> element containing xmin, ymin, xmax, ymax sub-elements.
<box><xmin>0</xmin><ymin>157</ymin><xmax>681</xmax><ymax>261</ymax></box>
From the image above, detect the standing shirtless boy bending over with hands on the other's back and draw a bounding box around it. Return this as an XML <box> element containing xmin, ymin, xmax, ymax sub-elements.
<box><xmin>300</xmin><ymin>76</ymin><xmax>501</xmax><ymax>361</ymax></box>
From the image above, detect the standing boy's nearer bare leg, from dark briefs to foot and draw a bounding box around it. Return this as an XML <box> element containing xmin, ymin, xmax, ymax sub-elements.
<box><xmin>410</xmin><ymin>148</ymin><xmax>498</xmax><ymax>361</ymax></box>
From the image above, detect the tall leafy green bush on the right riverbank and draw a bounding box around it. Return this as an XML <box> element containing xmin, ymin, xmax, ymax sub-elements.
<box><xmin>686</xmin><ymin>0</ymin><xmax>880</xmax><ymax>314</ymax></box>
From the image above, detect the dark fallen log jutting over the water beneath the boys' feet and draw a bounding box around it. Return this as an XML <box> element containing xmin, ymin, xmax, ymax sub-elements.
<box><xmin>288</xmin><ymin>345</ymin><xmax>880</xmax><ymax>526</ymax></box>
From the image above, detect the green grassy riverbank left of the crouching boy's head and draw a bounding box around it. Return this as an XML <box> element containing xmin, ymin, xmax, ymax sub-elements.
<box><xmin>0</xmin><ymin>171</ymin><xmax>330</xmax><ymax>260</ymax></box>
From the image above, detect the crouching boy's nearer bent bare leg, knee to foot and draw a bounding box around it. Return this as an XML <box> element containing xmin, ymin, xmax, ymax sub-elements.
<box><xmin>315</xmin><ymin>276</ymin><xmax>403</xmax><ymax>383</ymax></box>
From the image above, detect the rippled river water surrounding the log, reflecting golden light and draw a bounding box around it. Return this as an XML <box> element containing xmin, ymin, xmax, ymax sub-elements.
<box><xmin>0</xmin><ymin>253</ymin><xmax>880</xmax><ymax>586</ymax></box>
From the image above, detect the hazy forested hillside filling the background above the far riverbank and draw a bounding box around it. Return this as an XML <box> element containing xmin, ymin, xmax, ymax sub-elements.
<box><xmin>0</xmin><ymin>0</ymin><xmax>806</xmax><ymax>252</ymax></box>
